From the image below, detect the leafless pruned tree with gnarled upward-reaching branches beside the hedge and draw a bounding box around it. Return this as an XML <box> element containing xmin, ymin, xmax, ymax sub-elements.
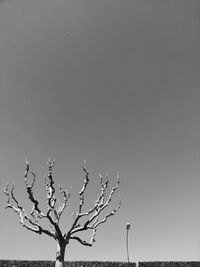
<box><xmin>4</xmin><ymin>159</ymin><xmax>121</xmax><ymax>267</ymax></box>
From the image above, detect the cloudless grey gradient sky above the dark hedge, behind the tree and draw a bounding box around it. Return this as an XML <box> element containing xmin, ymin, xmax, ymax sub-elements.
<box><xmin>0</xmin><ymin>0</ymin><xmax>200</xmax><ymax>261</ymax></box>
